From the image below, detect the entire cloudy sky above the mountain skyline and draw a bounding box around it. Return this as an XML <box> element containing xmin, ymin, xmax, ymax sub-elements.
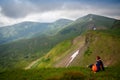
<box><xmin>0</xmin><ymin>0</ymin><xmax>120</xmax><ymax>27</ymax></box>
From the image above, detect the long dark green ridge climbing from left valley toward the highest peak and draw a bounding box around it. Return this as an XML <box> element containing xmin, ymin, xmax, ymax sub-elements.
<box><xmin>0</xmin><ymin>14</ymin><xmax>118</xmax><ymax>68</ymax></box>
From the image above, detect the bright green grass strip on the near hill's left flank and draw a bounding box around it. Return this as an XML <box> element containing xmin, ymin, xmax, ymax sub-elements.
<box><xmin>32</xmin><ymin>40</ymin><xmax>72</xmax><ymax>68</ymax></box>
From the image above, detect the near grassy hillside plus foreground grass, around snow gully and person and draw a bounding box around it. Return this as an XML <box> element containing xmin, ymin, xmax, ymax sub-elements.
<box><xmin>0</xmin><ymin>29</ymin><xmax>120</xmax><ymax>80</ymax></box>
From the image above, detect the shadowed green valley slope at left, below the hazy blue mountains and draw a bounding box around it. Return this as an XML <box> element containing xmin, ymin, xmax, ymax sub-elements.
<box><xmin>0</xmin><ymin>36</ymin><xmax>68</xmax><ymax>68</ymax></box>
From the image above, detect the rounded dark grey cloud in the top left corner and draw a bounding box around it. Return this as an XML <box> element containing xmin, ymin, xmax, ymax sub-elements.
<box><xmin>1</xmin><ymin>0</ymin><xmax>35</xmax><ymax>18</ymax></box>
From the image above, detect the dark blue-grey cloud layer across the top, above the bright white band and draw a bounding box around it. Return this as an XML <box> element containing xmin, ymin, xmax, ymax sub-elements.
<box><xmin>0</xmin><ymin>0</ymin><xmax>120</xmax><ymax>19</ymax></box>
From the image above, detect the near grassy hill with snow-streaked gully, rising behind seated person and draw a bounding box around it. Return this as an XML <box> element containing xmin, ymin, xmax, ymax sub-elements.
<box><xmin>31</xmin><ymin>29</ymin><xmax>120</xmax><ymax>68</ymax></box>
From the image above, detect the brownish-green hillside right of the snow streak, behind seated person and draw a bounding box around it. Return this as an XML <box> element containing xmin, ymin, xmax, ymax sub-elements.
<box><xmin>71</xmin><ymin>29</ymin><xmax>120</xmax><ymax>66</ymax></box>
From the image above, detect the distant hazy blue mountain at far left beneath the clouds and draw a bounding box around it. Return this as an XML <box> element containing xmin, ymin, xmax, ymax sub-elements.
<box><xmin>0</xmin><ymin>22</ymin><xmax>49</xmax><ymax>44</ymax></box>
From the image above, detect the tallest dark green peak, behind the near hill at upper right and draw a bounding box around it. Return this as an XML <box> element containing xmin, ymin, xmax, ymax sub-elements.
<box><xmin>60</xmin><ymin>14</ymin><xmax>115</xmax><ymax>36</ymax></box>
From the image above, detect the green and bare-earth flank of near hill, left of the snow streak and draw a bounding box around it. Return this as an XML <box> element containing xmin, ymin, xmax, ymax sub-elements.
<box><xmin>28</xmin><ymin>36</ymin><xmax>85</xmax><ymax>68</ymax></box>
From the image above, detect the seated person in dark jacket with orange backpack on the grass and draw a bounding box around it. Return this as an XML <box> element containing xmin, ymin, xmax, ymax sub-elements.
<box><xmin>88</xmin><ymin>56</ymin><xmax>104</xmax><ymax>72</ymax></box>
